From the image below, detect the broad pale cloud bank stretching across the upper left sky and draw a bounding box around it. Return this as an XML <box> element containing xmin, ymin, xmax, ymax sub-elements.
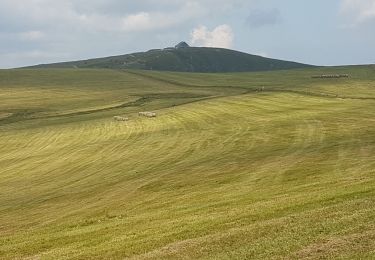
<box><xmin>0</xmin><ymin>0</ymin><xmax>209</xmax><ymax>32</ymax></box>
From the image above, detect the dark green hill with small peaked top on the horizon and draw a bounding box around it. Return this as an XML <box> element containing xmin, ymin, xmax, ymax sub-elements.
<box><xmin>29</xmin><ymin>42</ymin><xmax>312</xmax><ymax>72</ymax></box>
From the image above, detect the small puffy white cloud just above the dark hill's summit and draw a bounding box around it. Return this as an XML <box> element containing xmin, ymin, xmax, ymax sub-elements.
<box><xmin>191</xmin><ymin>24</ymin><xmax>234</xmax><ymax>48</ymax></box>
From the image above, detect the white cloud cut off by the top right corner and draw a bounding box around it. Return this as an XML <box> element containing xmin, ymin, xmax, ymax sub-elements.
<box><xmin>340</xmin><ymin>0</ymin><xmax>375</xmax><ymax>26</ymax></box>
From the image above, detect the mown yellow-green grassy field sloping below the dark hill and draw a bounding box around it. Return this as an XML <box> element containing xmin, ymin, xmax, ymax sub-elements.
<box><xmin>0</xmin><ymin>66</ymin><xmax>375</xmax><ymax>259</ymax></box>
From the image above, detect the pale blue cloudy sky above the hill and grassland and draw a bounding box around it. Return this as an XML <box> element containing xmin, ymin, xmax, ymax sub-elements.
<box><xmin>0</xmin><ymin>0</ymin><xmax>375</xmax><ymax>68</ymax></box>
